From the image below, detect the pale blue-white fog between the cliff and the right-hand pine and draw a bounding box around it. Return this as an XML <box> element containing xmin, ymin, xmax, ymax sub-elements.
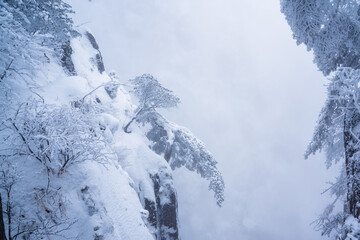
<box><xmin>69</xmin><ymin>0</ymin><xmax>336</xmax><ymax>240</ymax></box>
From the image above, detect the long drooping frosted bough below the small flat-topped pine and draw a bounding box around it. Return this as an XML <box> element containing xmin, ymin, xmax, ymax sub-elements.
<box><xmin>139</xmin><ymin>111</ymin><xmax>225</xmax><ymax>206</ymax></box>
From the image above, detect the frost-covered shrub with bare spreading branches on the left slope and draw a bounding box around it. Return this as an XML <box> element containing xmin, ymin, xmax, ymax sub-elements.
<box><xmin>3</xmin><ymin>102</ymin><xmax>107</xmax><ymax>175</ymax></box>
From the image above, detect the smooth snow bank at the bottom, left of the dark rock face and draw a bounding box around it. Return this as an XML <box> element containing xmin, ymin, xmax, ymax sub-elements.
<box><xmin>75</xmin><ymin>162</ymin><xmax>153</xmax><ymax>240</ymax></box>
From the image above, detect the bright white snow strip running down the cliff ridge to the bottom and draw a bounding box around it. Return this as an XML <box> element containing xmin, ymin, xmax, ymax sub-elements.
<box><xmin>59</xmin><ymin>30</ymin><xmax>160</xmax><ymax>240</ymax></box>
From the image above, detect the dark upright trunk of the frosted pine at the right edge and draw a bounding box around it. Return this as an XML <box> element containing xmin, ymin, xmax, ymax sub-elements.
<box><xmin>344</xmin><ymin>112</ymin><xmax>360</xmax><ymax>219</ymax></box>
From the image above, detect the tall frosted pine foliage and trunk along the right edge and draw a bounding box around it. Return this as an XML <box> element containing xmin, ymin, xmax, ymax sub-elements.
<box><xmin>281</xmin><ymin>0</ymin><xmax>360</xmax><ymax>239</ymax></box>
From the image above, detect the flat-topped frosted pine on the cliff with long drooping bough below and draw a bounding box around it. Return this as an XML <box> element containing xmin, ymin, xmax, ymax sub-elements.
<box><xmin>124</xmin><ymin>74</ymin><xmax>225</xmax><ymax>207</ymax></box>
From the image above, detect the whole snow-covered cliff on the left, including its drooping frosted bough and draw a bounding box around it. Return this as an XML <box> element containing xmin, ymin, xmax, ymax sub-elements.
<box><xmin>0</xmin><ymin>1</ymin><xmax>224</xmax><ymax>240</ymax></box>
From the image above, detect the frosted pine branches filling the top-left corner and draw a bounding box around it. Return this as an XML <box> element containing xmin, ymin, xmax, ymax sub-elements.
<box><xmin>0</xmin><ymin>0</ymin><xmax>78</xmax><ymax>85</ymax></box>
